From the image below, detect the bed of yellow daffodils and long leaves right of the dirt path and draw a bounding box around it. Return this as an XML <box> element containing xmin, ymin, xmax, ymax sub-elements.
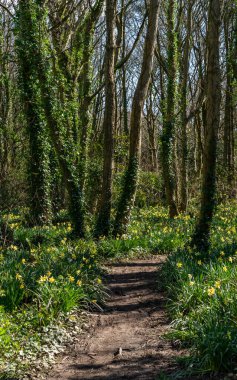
<box><xmin>161</xmin><ymin>201</ymin><xmax>237</xmax><ymax>373</ymax></box>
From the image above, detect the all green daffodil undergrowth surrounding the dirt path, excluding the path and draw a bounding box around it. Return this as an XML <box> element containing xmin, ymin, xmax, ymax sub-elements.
<box><xmin>0</xmin><ymin>202</ymin><xmax>237</xmax><ymax>378</ymax></box>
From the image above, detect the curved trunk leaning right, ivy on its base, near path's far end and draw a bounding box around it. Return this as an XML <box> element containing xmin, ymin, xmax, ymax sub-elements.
<box><xmin>114</xmin><ymin>0</ymin><xmax>159</xmax><ymax>235</ymax></box>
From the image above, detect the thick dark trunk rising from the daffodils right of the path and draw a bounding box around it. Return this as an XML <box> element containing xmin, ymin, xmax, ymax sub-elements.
<box><xmin>191</xmin><ymin>0</ymin><xmax>221</xmax><ymax>252</ymax></box>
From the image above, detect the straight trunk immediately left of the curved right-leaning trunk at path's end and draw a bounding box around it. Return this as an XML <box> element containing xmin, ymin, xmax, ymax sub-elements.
<box><xmin>95</xmin><ymin>0</ymin><xmax>117</xmax><ymax>237</ymax></box>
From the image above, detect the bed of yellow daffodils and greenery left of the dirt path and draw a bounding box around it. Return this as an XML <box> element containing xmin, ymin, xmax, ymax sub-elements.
<box><xmin>0</xmin><ymin>213</ymin><xmax>104</xmax><ymax>377</ymax></box>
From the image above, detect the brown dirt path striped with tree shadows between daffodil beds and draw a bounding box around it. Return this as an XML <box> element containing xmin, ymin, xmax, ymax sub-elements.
<box><xmin>48</xmin><ymin>256</ymin><xmax>185</xmax><ymax>380</ymax></box>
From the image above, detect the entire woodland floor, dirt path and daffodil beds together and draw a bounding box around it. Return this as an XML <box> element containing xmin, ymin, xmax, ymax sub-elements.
<box><xmin>0</xmin><ymin>208</ymin><xmax>237</xmax><ymax>380</ymax></box>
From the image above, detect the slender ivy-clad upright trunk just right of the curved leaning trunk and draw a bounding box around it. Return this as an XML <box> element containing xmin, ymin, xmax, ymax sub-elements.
<box><xmin>161</xmin><ymin>0</ymin><xmax>178</xmax><ymax>218</ymax></box>
